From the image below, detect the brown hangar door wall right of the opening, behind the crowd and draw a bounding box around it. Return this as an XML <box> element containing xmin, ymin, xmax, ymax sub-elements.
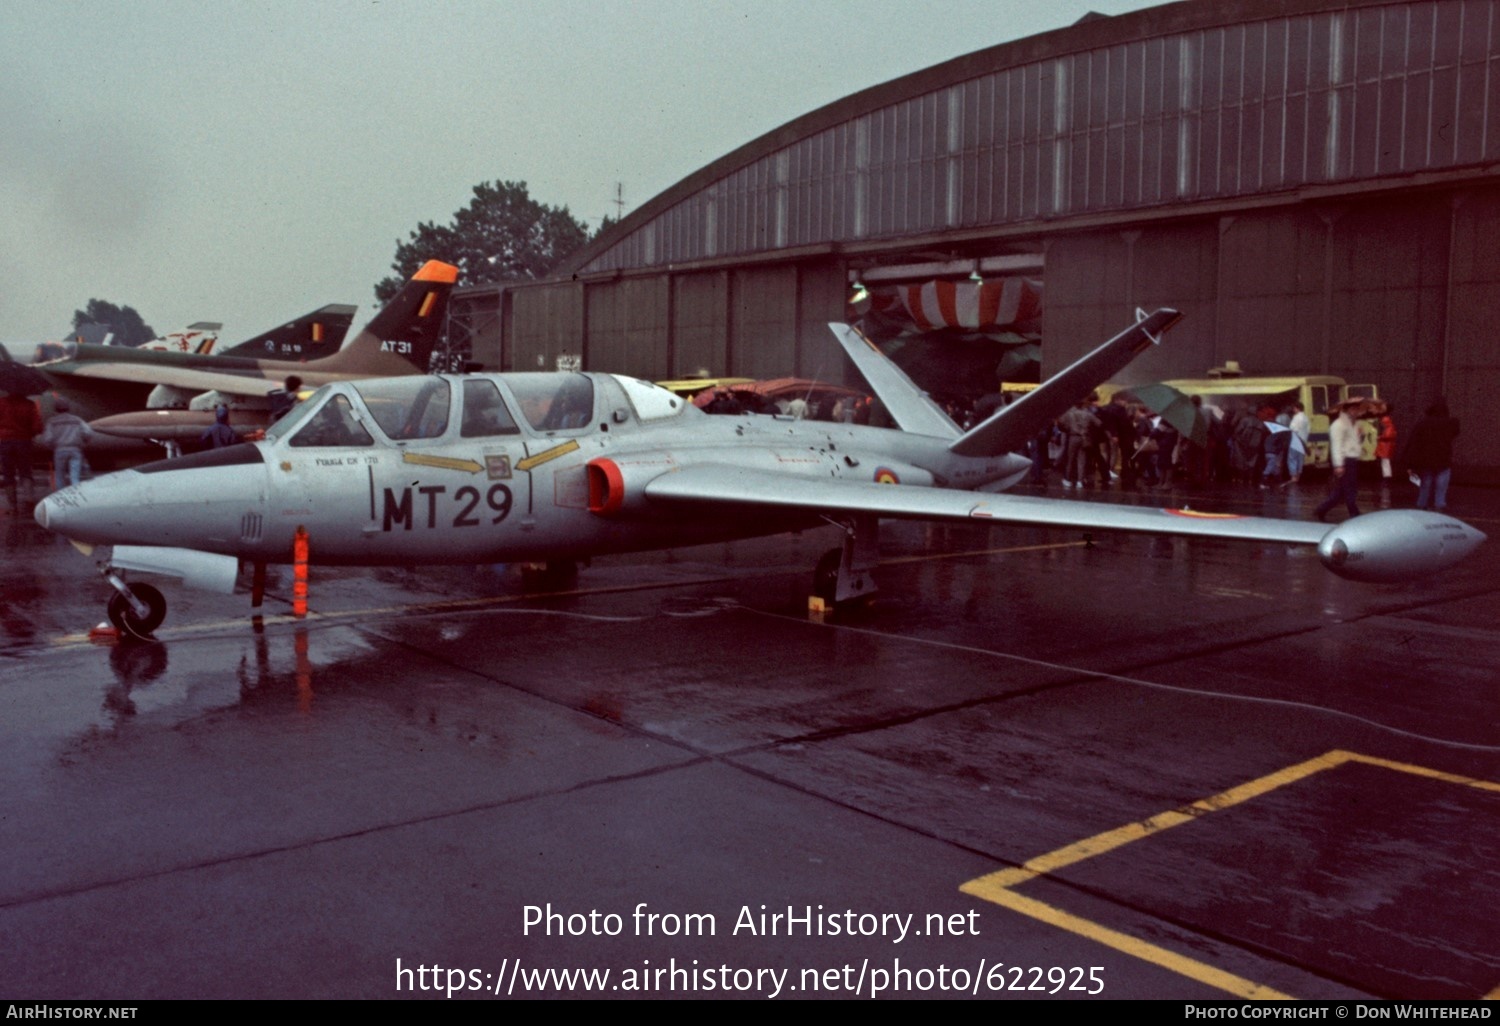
<box><xmin>1044</xmin><ymin>189</ymin><xmax>1500</xmax><ymax>480</ymax></box>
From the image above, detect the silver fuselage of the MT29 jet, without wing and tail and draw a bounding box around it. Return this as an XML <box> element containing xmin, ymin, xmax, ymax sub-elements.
<box><xmin>38</xmin><ymin>374</ymin><xmax>1029</xmax><ymax>566</ymax></box>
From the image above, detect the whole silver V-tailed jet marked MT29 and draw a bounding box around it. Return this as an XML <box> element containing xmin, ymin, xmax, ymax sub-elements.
<box><xmin>36</xmin><ymin>309</ymin><xmax>1485</xmax><ymax>636</ymax></box>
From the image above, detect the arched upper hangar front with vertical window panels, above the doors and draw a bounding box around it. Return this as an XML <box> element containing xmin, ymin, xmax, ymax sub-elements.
<box><xmin>566</xmin><ymin>0</ymin><xmax>1500</xmax><ymax>275</ymax></box>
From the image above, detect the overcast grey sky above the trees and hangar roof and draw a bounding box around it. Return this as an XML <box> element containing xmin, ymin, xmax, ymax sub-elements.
<box><xmin>0</xmin><ymin>0</ymin><xmax>1154</xmax><ymax>344</ymax></box>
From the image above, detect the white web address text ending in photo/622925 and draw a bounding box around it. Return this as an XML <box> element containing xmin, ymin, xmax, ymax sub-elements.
<box><xmin>396</xmin><ymin>957</ymin><xmax>1104</xmax><ymax>998</ymax></box>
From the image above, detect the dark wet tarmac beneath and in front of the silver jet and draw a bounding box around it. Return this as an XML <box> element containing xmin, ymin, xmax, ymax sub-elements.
<box><xmin>0</xmin><ymin>474</ymin><xmax>1500</xmax><ymax>1001</ymax></box>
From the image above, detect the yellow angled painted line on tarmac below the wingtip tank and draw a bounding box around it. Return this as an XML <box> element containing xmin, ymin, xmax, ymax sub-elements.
<box><xmin>959</xmin><ymin>749</ymin><xmax>1500</xmax><ymax>1001</ymax></box>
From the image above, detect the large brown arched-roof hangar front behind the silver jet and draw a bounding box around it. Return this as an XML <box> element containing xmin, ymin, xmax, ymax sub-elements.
<box><xmin>455</xmin><ymin>0</ymin><xmax>1500</xmax><ymax>480</ymax></box>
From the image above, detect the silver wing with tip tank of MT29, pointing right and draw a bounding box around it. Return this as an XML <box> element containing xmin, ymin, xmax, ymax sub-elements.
<box><xmin>645</xmin><ymin>464</ymin><xmax>1485</xmax><ymax>582</ymax></box>
